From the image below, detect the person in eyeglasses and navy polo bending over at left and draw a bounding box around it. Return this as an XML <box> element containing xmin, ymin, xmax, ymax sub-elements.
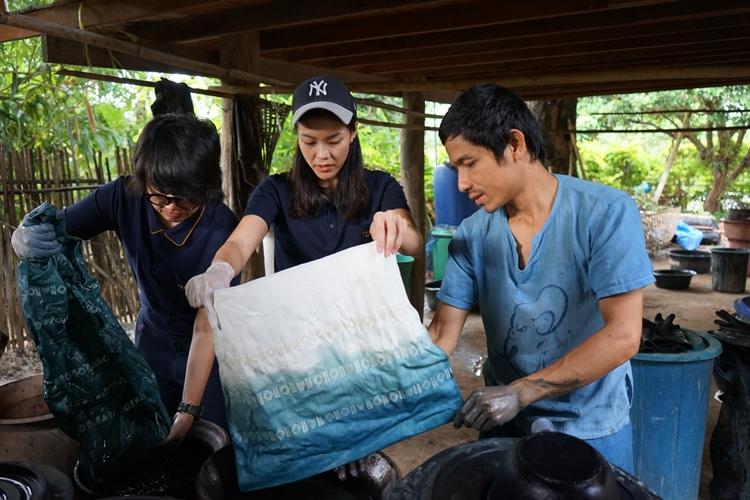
<box><xmin>12</xmin><ymin>114</ymin><xmax>238</xmax><ymax>440</ymax></box>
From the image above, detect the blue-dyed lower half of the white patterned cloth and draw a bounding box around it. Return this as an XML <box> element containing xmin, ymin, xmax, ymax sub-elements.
<box><xmin>224</xmin><ymin>332</ymin><xmax>462</xmax><ymax>491</ymax></box>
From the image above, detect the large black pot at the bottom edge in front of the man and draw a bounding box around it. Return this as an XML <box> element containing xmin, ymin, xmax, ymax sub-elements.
<box><xmin>385</xmin><ymin>438</ymin><xmax>659</xmax><ymax>500</ymax></box>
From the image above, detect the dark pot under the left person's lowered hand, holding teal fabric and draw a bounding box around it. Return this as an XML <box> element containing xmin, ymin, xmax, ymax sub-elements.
<box><xmin>74</xmin><ymin>420</ymin><xmax>229</xmax><ymax>500</ymax></box>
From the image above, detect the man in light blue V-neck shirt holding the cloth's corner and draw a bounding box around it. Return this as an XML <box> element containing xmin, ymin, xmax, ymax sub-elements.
<box><xmin>429</xmin><ymin>84</ymin><xmax>653</xmax><ymax>470</ymax></box>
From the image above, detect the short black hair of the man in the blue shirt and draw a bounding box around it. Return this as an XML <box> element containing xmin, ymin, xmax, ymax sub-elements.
<box><xmin>438</xmin><ymin>83</ymin><xmax>545</xmax><ymax>162</ymax></box>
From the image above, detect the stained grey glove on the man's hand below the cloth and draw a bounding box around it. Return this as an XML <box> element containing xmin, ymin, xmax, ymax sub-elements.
<box><xmin>453</xmin><ymin>385</ymin><xmax>523</xmax><ymax>431</ymax></box>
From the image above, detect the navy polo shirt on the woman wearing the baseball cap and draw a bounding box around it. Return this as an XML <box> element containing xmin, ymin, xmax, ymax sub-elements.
<box><xmin>245</xmin><ymin>170</ymin><xmax>409</xmax><ymax>271</ymax></box>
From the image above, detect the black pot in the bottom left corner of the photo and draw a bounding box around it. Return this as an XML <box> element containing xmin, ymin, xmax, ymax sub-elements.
<box><xmin>0</xmin><ymin>462</ymin><xmax>73</xmax><ymax>500</ymax></box>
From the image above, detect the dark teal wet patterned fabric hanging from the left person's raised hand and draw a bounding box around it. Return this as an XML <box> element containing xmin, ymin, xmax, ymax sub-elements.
<box><xmin>18</xmin><ymin>203</ymin><xmax>170</xmax><ymax>482</ymax></box>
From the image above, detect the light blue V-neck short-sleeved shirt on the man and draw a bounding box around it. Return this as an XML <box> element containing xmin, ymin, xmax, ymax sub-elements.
<box><xmin>438</xmin><ymin>175</ymin><xmax>654</xmax><ymax>439</ymax></box>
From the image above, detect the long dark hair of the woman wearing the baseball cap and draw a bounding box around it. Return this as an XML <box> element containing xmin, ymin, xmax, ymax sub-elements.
<box><xmin>288</xmin><ymin>109</ymin><xmax>369</xmax><ymax>219</ymax></box>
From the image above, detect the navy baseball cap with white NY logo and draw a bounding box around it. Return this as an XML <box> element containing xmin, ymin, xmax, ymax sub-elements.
<box><xmin>292</xmin><ymin>75</ymin><xmax>357</xmax><ymax>126</ymax></box>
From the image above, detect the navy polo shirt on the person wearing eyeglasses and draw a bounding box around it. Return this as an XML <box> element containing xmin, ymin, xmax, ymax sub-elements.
<box><xmin>63</xmin><ymin>176</ymin><xmax>239</xmax><ymax>336</ymax></box>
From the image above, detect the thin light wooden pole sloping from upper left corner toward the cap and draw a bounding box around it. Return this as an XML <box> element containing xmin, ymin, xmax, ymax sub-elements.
<box><xmin>0</xmin><ymin>13</ymin><xmax>289</xmax><ymax>85</ymax></box>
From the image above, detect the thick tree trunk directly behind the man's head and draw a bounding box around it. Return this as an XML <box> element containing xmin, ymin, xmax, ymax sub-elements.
<box><xmin>528</xmin><ymin>99</ymin><xmax>578</xmax><ymax>175</ymax></box>
